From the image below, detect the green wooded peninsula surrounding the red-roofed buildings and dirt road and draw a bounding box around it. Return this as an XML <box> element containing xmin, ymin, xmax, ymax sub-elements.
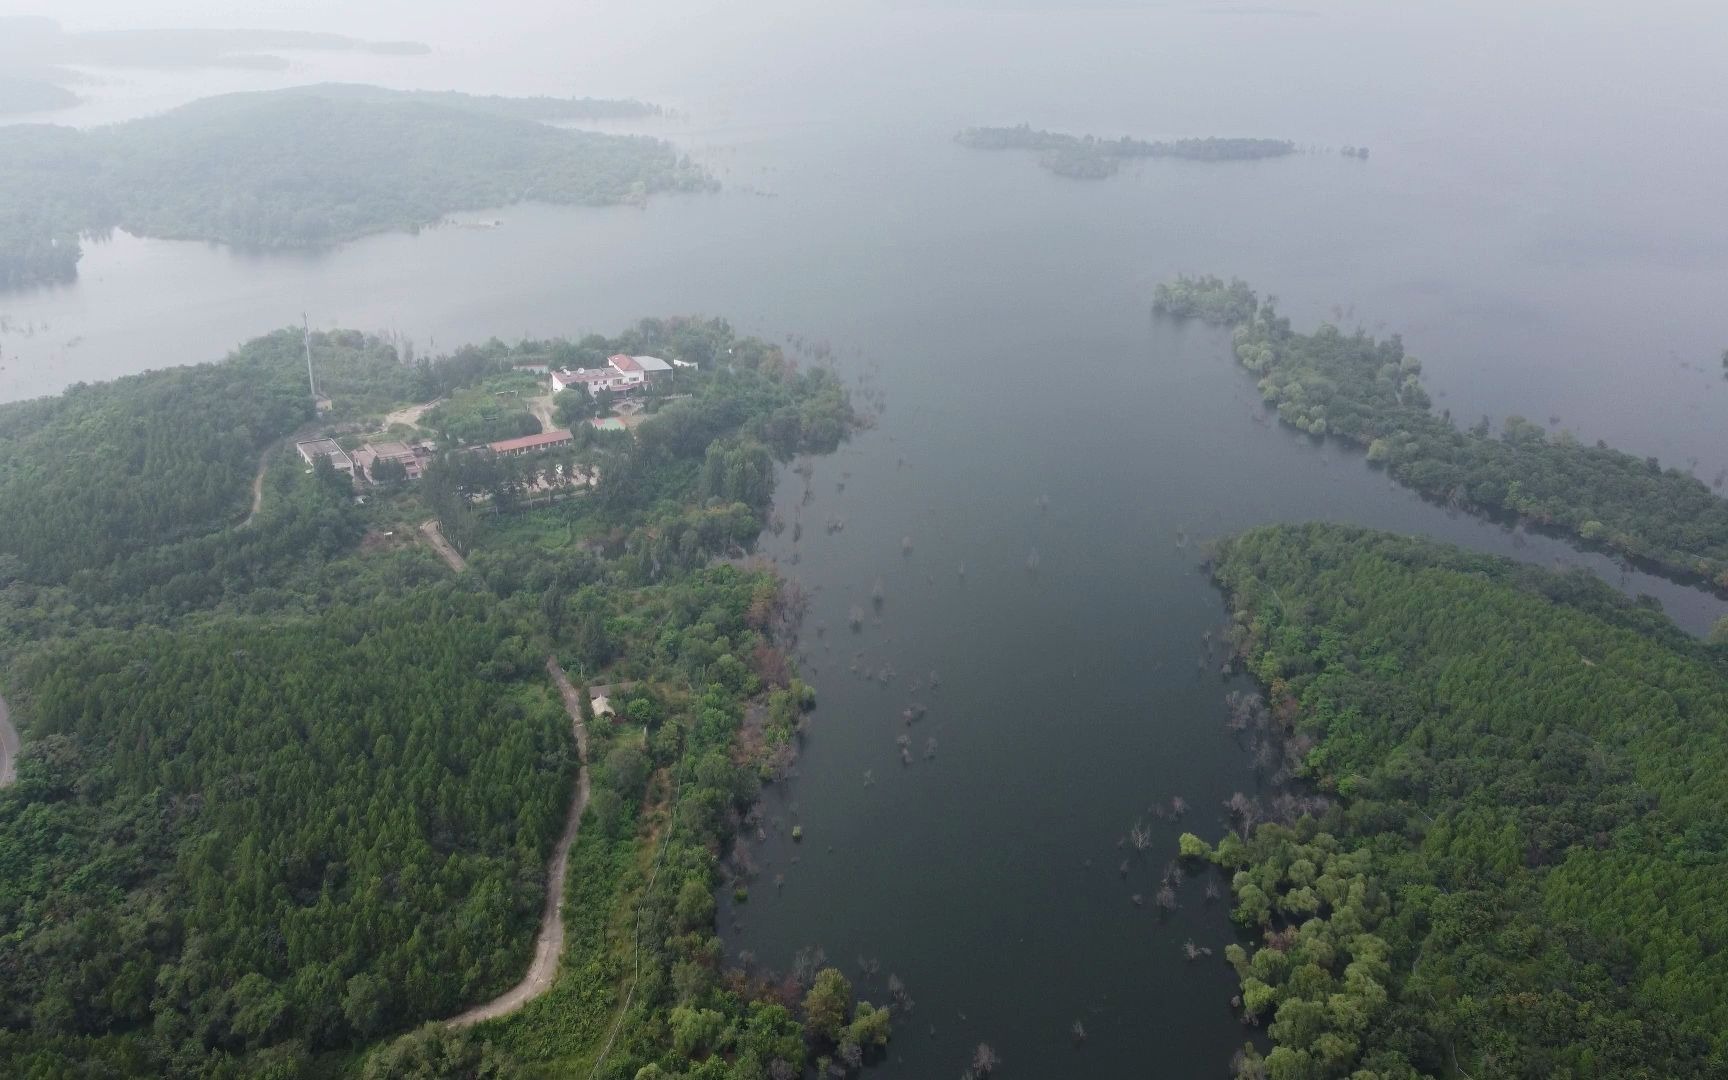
<box><xmin>0</xmin><ymin>318</ymin><xmax>892</xmax><ymax>1080</ymax></box>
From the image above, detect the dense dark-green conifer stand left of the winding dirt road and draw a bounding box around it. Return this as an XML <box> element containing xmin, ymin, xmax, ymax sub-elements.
<box><xmin>0</xmin><ymin>586</ymin><xmax>570</xmax><ymax>1075</ymax></box>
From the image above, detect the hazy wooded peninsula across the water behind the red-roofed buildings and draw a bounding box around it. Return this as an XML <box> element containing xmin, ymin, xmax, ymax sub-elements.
<box><xmin>0</xmin><ymin>85</ymin><xmax>714</xmax><ymax>287</ymax></box>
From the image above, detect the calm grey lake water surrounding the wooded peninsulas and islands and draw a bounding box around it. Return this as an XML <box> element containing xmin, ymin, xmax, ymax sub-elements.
<box><xmin>10</xmin><ymin>0</ymin><xmax>1728</xmax><ymax>1077</ymax></box>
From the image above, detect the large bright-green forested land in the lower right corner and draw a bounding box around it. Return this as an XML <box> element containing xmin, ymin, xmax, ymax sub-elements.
<box><xmin>1184</xmin><ymin>525</ymin><xmax>1728</xmax><ymax>1080</ymax></box>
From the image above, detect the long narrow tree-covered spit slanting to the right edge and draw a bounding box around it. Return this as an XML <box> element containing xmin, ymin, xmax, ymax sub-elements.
<box><xmin>1154</xmin><ymin>278</ymin><xmax>1728</xmax><ymax>589</ymax></box>
